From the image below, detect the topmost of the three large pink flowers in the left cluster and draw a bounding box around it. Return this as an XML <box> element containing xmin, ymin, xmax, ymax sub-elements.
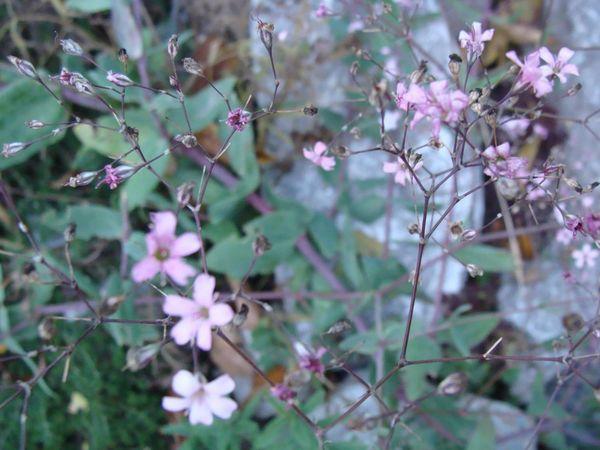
<box><xmin>131</xmin><ymin>211</ymin><xmax>200</xmax><ymax>285</ymax></box>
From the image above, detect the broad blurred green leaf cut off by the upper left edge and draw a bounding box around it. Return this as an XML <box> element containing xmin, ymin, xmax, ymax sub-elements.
<box><xmin>0</xmin><ymin>78</ymin><xmax>65</xmax><ymax>170</ymax></box>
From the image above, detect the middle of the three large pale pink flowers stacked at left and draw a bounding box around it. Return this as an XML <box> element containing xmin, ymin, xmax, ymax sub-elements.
<box><xmin>163</xmin><ymin>273</ymin><xmax>233</xmax><ymax>351</ymax></box>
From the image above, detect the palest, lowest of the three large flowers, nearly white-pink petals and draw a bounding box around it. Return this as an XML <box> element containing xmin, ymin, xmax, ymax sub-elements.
<box><xmin>162</xmin><ymin>370</ymin><xmax>237</xmax><ymax>425</ymax></box>
